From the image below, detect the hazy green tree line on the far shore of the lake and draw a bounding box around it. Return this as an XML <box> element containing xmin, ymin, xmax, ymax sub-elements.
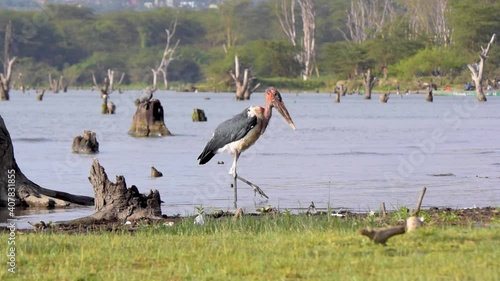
<box><xmin>0</xmin><ymin>0</ymin><xmax>500</xmax><ymax>90</ymax></box>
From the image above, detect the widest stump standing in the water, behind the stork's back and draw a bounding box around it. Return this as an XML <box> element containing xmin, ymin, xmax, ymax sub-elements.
<box><xmin>129</xmin><ymin>99</ymin><xmax>172</xmax><ymax>137</ymax></box>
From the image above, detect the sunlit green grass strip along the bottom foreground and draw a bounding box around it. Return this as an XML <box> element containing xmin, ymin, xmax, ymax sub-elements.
<box><xmin>0</xmin><ymin>215</ymin><xmax>500</xmax><ymax>280</ymax></box>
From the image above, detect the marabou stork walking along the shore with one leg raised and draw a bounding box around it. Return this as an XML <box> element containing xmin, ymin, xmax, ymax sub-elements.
<box><xmin>198</xmin><ymin>87</ymin><xmax>295</xmax><ymax>208</ymax></box>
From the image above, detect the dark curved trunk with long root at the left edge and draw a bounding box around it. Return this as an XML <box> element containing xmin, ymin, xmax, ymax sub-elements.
<box><xmin>0</xmin><ymin>112</ymin><xmax>94</xmax><ymax>208</ymax></box>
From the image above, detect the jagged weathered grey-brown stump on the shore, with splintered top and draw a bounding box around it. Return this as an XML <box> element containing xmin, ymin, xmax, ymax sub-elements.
<box><xmin>60</xmin><ymin>159</ymin><xmax>162</xmax><ymax>225</ymax></box>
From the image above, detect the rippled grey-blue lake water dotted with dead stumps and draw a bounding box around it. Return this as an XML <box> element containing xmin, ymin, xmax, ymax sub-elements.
<box><xmin>0</xmin><ymin>91</ymin><xmax>500</xmax><ymax>226</ymax></box>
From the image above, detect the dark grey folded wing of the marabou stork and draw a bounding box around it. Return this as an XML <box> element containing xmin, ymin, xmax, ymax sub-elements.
<box><xmin>198</xmin><ymin>108</ymin><xmax>257</xmax><ymax>165</ymax></box>
